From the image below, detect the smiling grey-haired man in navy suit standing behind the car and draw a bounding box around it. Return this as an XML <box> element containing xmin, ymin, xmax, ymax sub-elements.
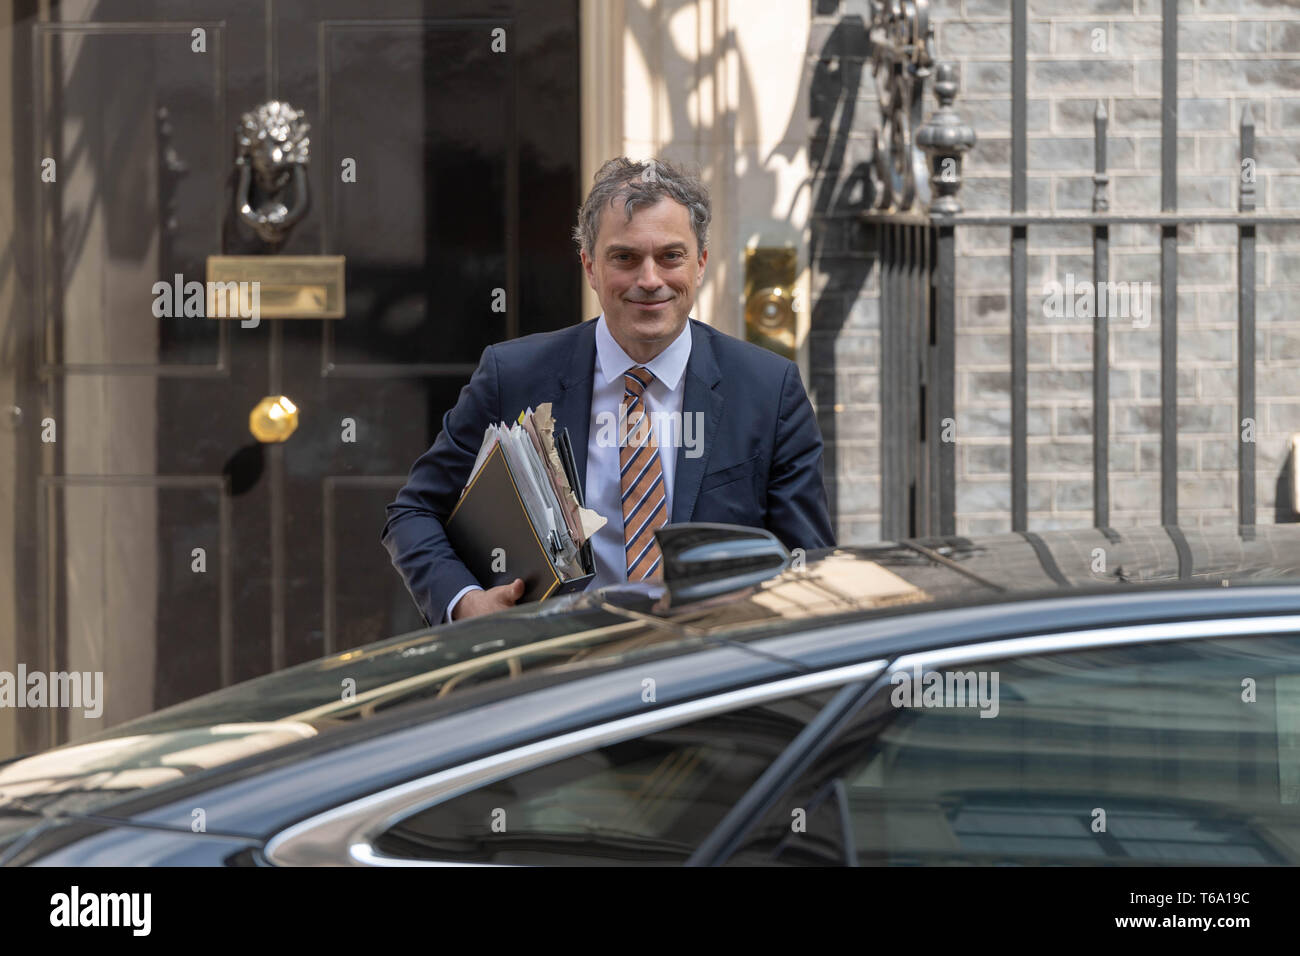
<box><xmin>382</xmin><ymin>157</ymin><xmax>835</xmax><ymax>624</ymax></box>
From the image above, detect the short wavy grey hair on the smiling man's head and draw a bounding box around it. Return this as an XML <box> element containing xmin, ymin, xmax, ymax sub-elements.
<box><xmin>573</xmin><ymin>156</ymin><xmax>712</xmax><ymax>256</ymax></box>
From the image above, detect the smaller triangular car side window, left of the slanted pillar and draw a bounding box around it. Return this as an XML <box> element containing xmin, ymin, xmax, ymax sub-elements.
<box><xmin>374</xmin><ymin>688</ymin><xmax>839</xmax><ymax>865</ymax></box>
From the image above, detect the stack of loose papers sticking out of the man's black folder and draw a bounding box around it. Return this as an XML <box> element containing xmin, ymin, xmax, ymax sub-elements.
<box><xmin>465</xmin><ymin>402</ymin><xmax>606</xmax><ymax>578</ymax></box>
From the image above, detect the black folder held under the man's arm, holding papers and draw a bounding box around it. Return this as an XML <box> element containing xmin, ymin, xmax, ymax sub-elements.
<box><xmin>445</xmin><ymin>432</ymin><xmax>595</xmax><ymax>604</ymax></box>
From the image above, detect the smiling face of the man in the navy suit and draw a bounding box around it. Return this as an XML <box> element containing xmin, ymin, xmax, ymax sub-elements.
<box><xmin>582</xmin><ymin>198</ymin><xmax>709</xmax><ymax>363</ymax></box>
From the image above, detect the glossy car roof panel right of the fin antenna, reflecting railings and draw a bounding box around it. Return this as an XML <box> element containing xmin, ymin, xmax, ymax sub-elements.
<box><xmin>605</xmin><ymin>524</ymin><xmax>1300</xmax><ymax>640</ymax></box>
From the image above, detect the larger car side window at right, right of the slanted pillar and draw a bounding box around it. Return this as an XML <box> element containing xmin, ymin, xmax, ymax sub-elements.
<box><xmin>727</xmin><ymin>635</ymin><xmax>1300</xmax><ymax>865</ymax></box>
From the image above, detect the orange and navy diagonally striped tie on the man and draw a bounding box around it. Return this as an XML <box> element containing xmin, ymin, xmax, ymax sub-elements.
<box><xmin>619</xmin><ymin>365</ymin><xmax>668</xmax><ymax>581</ymax></box>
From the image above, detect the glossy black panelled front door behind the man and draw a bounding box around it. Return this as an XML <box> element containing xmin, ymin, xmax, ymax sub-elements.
<box><xmin>0</xmin><ymin>0</ymin><xmax>582</xmax><ymax>749</ymax></box>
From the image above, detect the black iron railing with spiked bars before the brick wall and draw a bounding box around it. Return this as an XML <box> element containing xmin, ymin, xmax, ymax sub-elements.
<box><xmin>865</xmin><ymin>0</ymin><xmax>1300</xmax><ymax>537</ymax></box>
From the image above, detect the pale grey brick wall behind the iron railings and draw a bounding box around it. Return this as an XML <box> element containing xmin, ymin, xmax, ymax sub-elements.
<box><xmin>809</xmin><ymin>0</ymin><xmax>1300</xmax><ymax>542</ymax></box>
